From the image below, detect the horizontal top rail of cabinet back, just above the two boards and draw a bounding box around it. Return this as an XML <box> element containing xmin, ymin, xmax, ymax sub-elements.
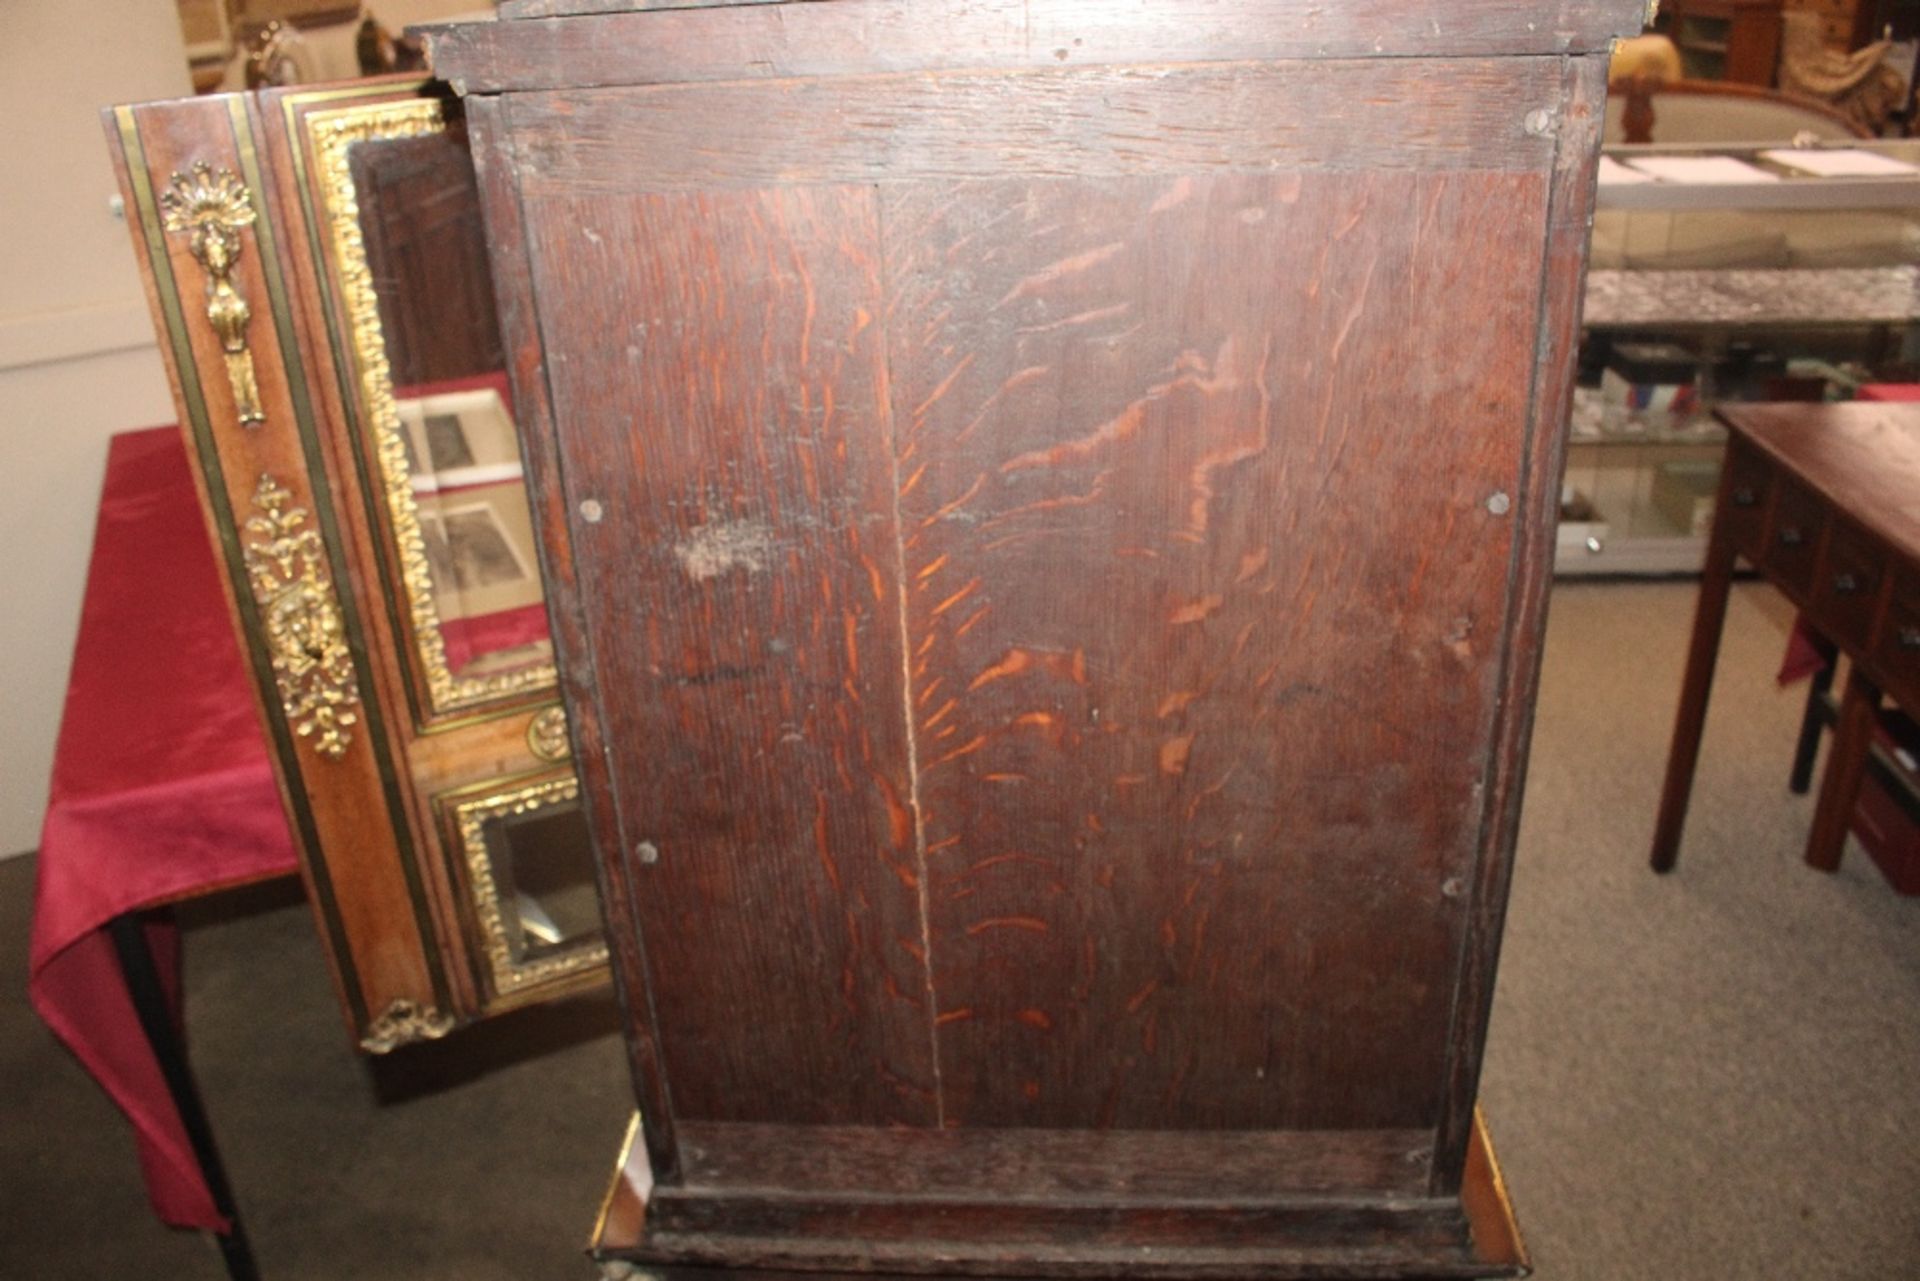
<box><xmin>511</xmin><ymin>58</ymin><xmax>1561</xmax><ymax>196</ymax></box>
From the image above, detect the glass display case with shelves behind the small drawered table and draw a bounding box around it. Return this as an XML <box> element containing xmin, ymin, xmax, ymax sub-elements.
<box><xmin>1557</xmin><ymin>142</ymin><xmax>1920</xmax><ymax>574</ymax></box>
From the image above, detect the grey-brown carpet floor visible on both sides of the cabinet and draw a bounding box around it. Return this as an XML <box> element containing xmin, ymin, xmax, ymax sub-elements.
<box><xmin>0</xmin><ymin>584</ymin><xmax>1920</xmax><ymax>1281</ymax></box>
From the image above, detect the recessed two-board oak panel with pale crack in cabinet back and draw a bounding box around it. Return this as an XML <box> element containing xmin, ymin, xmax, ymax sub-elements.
<box><xmin>511</xmin><ymin>65</ymin><xmax>1548</xmax><ymax>1129</ymax></box>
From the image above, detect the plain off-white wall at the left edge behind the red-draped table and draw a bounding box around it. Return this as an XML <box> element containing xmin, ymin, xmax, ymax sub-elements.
<box><xmin>0</xmin><ymin>0</ymin><xmax>190</xmax><ymax>857</ymax></box>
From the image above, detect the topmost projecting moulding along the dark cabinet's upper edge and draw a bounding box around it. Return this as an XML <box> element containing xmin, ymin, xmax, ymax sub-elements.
<box><xmin>419</xmin><ymin>0</ymin><xmax>1645</xmax><ymax>95</ymax></box>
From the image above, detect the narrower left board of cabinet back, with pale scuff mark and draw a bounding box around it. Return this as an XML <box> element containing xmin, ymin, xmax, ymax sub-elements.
<box><xmin>534</xmin><ymin>188</ymin><xmax>937</xmax><ymax>1124</ymax></box>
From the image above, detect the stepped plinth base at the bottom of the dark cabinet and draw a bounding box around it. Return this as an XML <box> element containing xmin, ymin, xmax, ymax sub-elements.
<box><xmin>591</xmin><ymin>1125</ymin><xmax>1526</xmax><ymax>1281</ymax></box>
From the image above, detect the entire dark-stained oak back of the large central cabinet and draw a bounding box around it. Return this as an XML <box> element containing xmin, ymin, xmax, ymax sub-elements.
<box><xmin>451</xmin><ymin>0</ymin><xmax>1624</xmax><ymax>1277</ymax></box>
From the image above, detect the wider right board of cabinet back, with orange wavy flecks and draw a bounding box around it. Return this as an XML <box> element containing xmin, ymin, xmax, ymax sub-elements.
<box><xmin>885</xmin><ymin>173</ymin><xmax>1544</xmax><ymax>1129</ymax></box>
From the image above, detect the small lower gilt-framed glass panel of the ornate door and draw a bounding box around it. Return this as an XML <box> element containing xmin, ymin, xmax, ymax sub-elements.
<box><xmin>440</xmin><ymin>774</ymin><xmax>607</xmax><ymax>997</ymax></box>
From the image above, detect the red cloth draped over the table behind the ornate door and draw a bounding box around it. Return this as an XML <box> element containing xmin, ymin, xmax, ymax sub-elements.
<box><xmin>29</xmin><ymin>426</ymin><xmax>296</xmax><ymax>1231</ymax></box>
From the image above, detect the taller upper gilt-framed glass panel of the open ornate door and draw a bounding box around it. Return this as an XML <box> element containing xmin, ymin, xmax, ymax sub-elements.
<box><xmin>307</xmin><ymin>98</ymin><xmax>555</xmax><ymax>718</ymax></box>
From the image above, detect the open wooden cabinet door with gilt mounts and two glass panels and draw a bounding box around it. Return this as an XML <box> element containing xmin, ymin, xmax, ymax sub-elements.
<box><xmin>106</xmin><ymin>79</ymin><xmax>607</xmax><ymax>1052</ymax></box>
